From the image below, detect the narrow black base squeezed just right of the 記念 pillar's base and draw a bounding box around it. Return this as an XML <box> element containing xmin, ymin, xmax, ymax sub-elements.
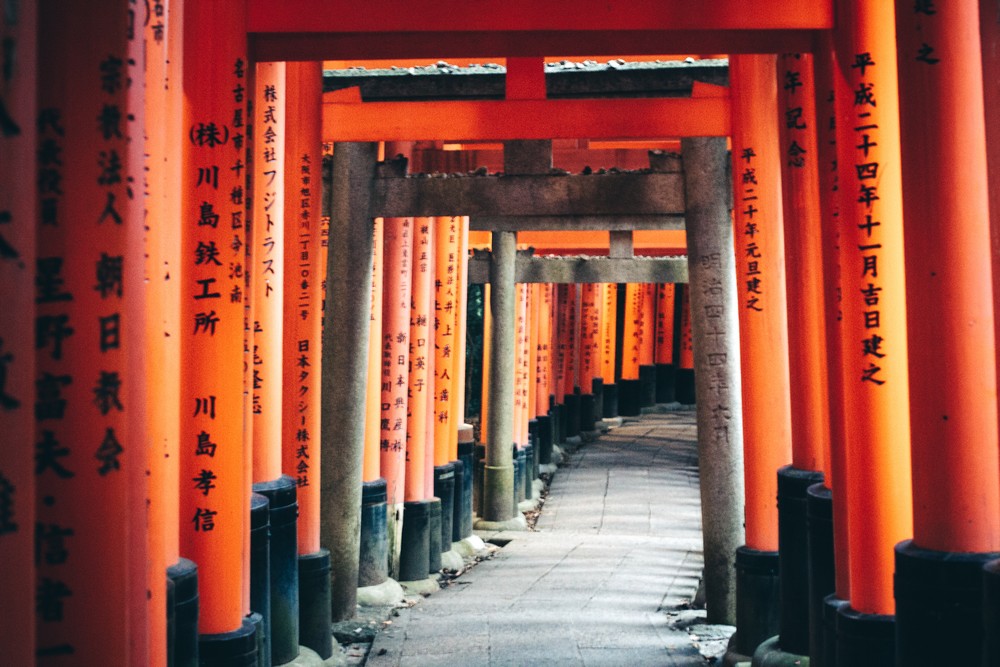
<box><xmin>806</xmin><ymin>484</ymin><xmax>836</xmax><ymax>667</ymax></box>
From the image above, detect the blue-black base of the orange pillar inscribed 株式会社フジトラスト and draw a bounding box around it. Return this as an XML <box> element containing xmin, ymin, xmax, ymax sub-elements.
<box><xmin>253</xmin><ymin>475</ymin><xmax>299</xmax><ymax>665</ymax></box>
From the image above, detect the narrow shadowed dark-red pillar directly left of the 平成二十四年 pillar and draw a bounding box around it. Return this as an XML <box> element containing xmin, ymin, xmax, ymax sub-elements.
<box><xmin>810</xmin><ymin>33</ymin><xmax>851</xmax><ymax>662</ymax></box>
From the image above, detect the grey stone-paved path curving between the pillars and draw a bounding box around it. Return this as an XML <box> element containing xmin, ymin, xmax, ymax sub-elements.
<box><xmin>367</xmin><ymin>411</ymin><xmax>732</xmax><ymax>667</ymax></box>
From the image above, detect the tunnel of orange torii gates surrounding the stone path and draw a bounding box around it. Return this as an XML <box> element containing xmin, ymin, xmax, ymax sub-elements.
<box><xmin>0</xmin><ymin>0</ymin><xmax>1000</xmax><ymax>666</ymax></box>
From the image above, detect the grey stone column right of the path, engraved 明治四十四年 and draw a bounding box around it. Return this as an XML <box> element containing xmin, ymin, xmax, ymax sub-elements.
<box><xmin>681</xmin><ymin>137</ymin><xmax>745</xmax><ymax>625</ymax></box>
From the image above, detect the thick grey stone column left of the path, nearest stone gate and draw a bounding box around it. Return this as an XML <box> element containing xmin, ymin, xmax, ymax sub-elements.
<box><xmin>320</xmin><ymin>143</ymin><xmax>378</xmax><ymax>621</ymax></box>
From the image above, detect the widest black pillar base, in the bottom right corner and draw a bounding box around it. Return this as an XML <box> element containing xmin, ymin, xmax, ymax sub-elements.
<box><xmin>894</xmin><ymin>540</ymin><xmax>1000</xmax><ymax>665</ymax></box>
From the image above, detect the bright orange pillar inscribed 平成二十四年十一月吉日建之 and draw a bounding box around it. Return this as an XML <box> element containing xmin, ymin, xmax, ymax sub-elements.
<box><xmin>835</xmin><ymin>0</ymin><xmax>913</xmax><ymax>636</ymax></box>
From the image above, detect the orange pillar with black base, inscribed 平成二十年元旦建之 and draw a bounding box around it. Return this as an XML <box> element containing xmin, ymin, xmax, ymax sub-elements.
<box><xmin>730</xmin><ymin>55</ymin><xmax>792</xmax><ymax>655</ymax></box>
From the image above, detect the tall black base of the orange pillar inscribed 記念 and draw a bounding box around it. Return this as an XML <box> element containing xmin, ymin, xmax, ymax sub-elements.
<box><xmin>778</xmin><ymin>466</ymin><xmax>823</xmax><ymax>655</ymax></box>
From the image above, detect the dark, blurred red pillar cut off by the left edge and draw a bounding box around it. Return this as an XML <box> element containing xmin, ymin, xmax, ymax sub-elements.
<box><xmin>0</xmin><ymin>3</ymin><xmax>36</xmax><ymax>665</ymax></box>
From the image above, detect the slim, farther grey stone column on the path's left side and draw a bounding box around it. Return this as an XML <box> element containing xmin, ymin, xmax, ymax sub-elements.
<box><xmin>483</xmin><ymin>232</ymin><xmax>517</xmax><ymax>521</ymax></box>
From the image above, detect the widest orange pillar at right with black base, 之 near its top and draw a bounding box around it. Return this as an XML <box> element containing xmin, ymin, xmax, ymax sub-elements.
<box><xmin>896</xmin><ymin>3</ymin><xmax>1000</xmax><ymax>664</ymax></box>
